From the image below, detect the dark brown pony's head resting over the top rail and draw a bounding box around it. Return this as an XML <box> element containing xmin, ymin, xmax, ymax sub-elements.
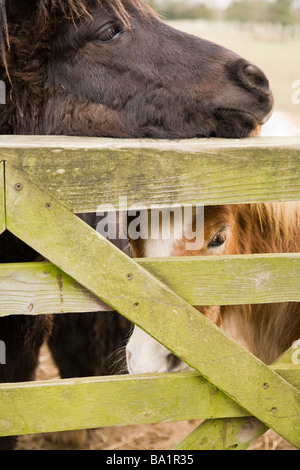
<box><xmin>0</xmin><ymin>0</ymin><xmax>273</xmax><ymax>138</ymax></box>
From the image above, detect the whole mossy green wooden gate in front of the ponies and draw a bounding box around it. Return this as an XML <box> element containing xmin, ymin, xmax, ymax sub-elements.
<box><xmin>0</xmin><ymin>136</ymin><xmax>300</xmax><ymax>449</ymax></box>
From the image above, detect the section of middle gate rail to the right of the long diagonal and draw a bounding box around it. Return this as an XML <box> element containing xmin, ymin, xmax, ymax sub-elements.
<box><xmin>137</xmin><ymin>253</ymin><xmax>300</xmax><ymax>305</ymax></box>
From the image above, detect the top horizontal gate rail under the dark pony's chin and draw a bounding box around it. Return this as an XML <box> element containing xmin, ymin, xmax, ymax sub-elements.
<box><xmin>0</xmin><ymin>136</ymin><xmax>300</xmax><ymax>212</ymax></box>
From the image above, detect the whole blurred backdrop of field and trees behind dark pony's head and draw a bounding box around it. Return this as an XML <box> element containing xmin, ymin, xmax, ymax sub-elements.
<box><xmin>148</xmin><ymin>0</ymin><xmax>300</xmax><ymax>119</ymax></box>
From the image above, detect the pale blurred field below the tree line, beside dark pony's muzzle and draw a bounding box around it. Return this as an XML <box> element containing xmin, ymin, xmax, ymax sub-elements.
<box><xmin>169</xmin><ymin>21</ymin><xmax>300</xmax><ymax>118</ymax></box>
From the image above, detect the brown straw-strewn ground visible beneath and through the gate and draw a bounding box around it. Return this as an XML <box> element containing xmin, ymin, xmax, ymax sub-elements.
<box><xmin>17</xmin><ymin>347</ymin><xmax>296</xmax><ymax>450</ymax></box>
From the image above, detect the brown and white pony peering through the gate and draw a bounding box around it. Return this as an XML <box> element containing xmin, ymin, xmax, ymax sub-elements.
<box><xmin>126</xmin><ymin>113</ymin><xmax>300</xmax><ymax>373</ymax></box>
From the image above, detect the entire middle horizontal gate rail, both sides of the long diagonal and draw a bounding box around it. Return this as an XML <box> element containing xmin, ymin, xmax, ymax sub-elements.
<box><xmin>0</xmin><ymin>253</ymin><xmax>300</xmax><ymax>316</ymax></box>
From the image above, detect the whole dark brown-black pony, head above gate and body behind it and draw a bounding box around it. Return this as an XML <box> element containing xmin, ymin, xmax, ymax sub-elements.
<box><xmin>0</xmin><ymin>0</ymin><xmax>273</xmax><ymax>448</ymax></box>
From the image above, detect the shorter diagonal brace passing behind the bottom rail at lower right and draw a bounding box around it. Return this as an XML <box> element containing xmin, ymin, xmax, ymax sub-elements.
<box><xmin>174</xmin><ymin>340</ymin><xmax>300</xmax><ymax>450</ymax></box>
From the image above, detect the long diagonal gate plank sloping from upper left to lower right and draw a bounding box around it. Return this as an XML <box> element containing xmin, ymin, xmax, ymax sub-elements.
<box><xmin>6</xmin><ymin>165</ymin><xmax>300</xmax><ymax>447</ymax></box>
